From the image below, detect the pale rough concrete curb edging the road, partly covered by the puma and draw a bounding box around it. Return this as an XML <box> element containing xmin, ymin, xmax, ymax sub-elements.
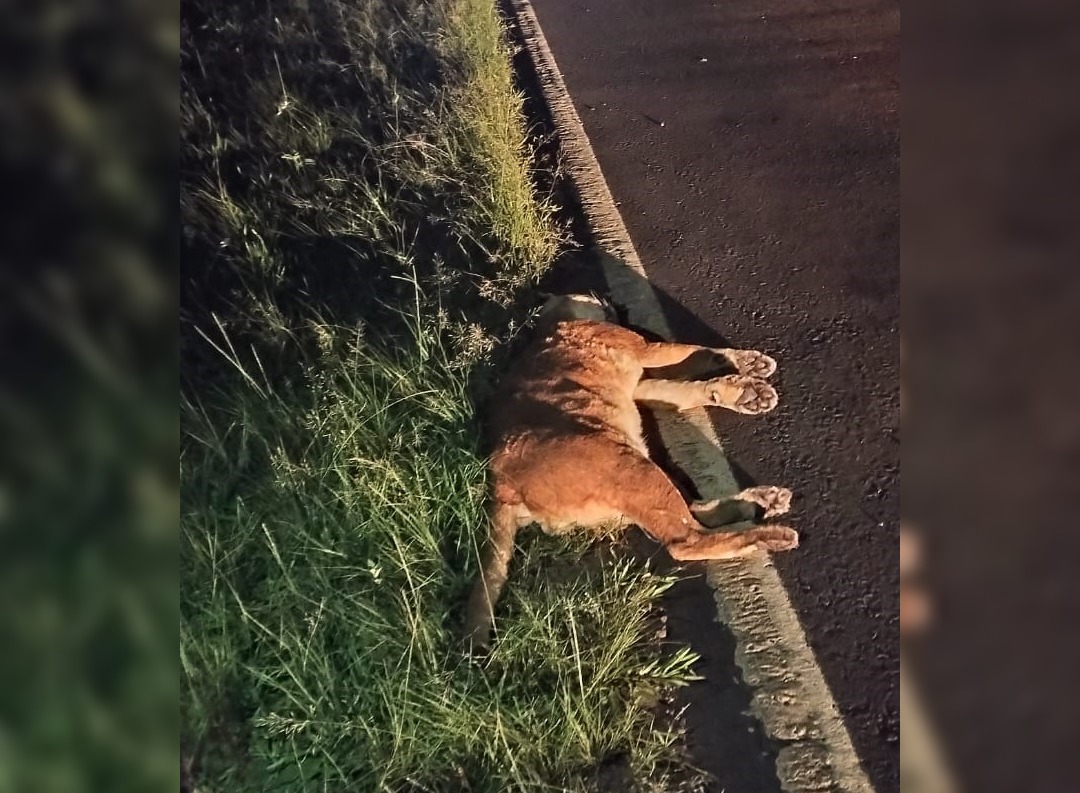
<box><xmin>507</xmin><ymin>0</ymin><xmax>873</xmax><ymax>793</ymax></box>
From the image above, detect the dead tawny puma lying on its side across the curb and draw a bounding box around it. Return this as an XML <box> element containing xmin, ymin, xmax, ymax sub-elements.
<box><xmin>464</xmin><ymin>295</ymin><xmax>798</xmax><ymax>647</ymax></box>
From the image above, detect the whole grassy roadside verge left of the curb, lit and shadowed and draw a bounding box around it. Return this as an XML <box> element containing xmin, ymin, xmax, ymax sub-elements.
<box><xmin>180</xmin><ymin>0</ymin><xmax>693</xmax><ymax>793</ymax></box>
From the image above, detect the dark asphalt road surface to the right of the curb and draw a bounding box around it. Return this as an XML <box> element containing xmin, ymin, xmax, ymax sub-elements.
<box><xmin>534</xmin><ymin>0</ymin><xmax>900</xmax><ymax>793</ymax></box>
